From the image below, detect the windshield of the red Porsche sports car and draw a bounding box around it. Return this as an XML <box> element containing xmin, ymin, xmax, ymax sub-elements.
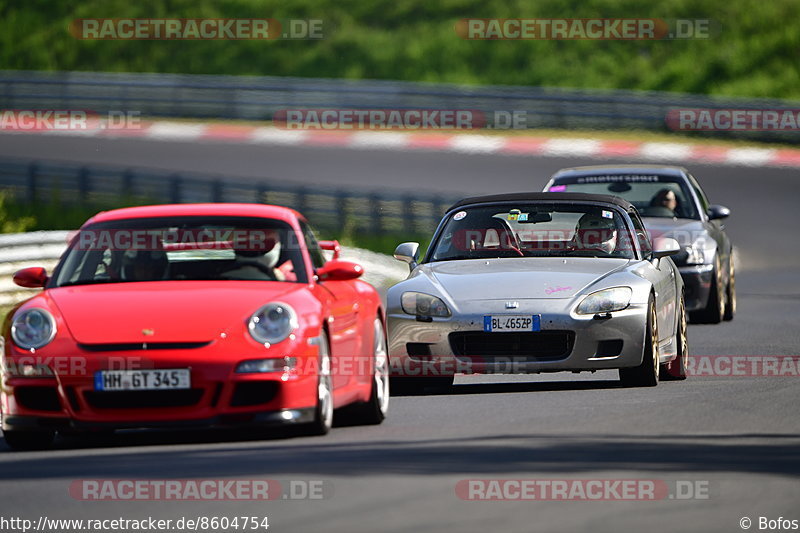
<box><xmin>51</xmin><ymin>216</ymin><xmax>308</xmax><ymax>287</ymax></box>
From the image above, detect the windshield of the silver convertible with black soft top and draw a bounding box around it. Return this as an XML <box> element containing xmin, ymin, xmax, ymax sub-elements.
<box><xmin>428</xmin><ymin>203</ymin><xmax>635</xmax><ymax>261</ymax></box>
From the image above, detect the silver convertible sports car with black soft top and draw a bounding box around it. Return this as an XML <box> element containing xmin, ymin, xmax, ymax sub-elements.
<box><xmin>387</xmin><ymin>193</ymin><xmax>688</xmax><ymax>390</ymax></box>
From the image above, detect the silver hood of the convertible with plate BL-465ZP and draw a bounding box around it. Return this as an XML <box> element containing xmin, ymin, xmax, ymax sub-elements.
<box><xmin>418</xmin><ymin>257</ymin><xmax>629</xmax><ymax>301</ymax></box>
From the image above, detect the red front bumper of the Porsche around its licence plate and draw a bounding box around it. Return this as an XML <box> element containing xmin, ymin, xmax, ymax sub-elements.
<box><xmin>0</xmin><ymin>338</ymin><xmax>318</xmax><ymax>430</ymax></box>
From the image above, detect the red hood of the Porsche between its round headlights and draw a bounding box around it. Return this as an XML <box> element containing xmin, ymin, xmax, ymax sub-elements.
<box><xmin>47</xmin><ymin>281</ymin><xmax>306</xmax><ymax>344</ymax></box>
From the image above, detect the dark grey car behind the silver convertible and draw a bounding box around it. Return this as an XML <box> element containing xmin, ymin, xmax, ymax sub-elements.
<box><xmin>544</xmin><ymin>165</ymin><xmax>736</xmax><ymax>324</ymax></box>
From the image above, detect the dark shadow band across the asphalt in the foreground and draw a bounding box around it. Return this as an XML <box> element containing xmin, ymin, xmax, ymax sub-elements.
<box><xmin>0</xmin><ymin>432</ymin><xmax>800</xmax><ymax>480</ymax></box>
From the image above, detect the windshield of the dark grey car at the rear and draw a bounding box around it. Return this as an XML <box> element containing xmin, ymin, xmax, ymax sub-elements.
<box><xmin>549</xmin><ymin>174</ymin><xmax>700</xmax><ymax>220</ymax></box>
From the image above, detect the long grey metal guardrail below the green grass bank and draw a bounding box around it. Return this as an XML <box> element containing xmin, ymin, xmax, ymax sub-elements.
<box><xmin>0</xmin><ymin>70</ymin><xmax>800</xmax><ymax>143</ymax></box>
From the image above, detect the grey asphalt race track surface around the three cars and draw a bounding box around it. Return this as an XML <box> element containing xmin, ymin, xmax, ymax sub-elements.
<box><xmin>0</xmin><ymin>130</ymin><xmax>800</xmax><ymax>532</ymax></box>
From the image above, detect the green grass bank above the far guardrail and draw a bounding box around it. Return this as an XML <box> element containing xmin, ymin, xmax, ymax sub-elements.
<box><xmin>0</xmin><ymin>0</ymin><xmax>800</xmax><ymax>99</ymax></box>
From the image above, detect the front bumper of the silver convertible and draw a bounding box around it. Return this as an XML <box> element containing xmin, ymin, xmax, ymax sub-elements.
<box><xmin>387</xmin><ymin>299</ymin><xmax>647</xmax><ymax>376</ymax></box>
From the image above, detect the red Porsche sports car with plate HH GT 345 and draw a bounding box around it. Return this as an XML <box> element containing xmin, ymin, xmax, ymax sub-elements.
<box><xmin>0</xmin><ymin>204</ymin><xmax>389</xmax><ymax>449</ymax></box>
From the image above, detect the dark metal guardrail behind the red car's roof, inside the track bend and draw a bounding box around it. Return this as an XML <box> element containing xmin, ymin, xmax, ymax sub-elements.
<box><xmin>0</xmin><ymin>159</ymin><xmax>457</xmax><ymax>235</ymax></box>
